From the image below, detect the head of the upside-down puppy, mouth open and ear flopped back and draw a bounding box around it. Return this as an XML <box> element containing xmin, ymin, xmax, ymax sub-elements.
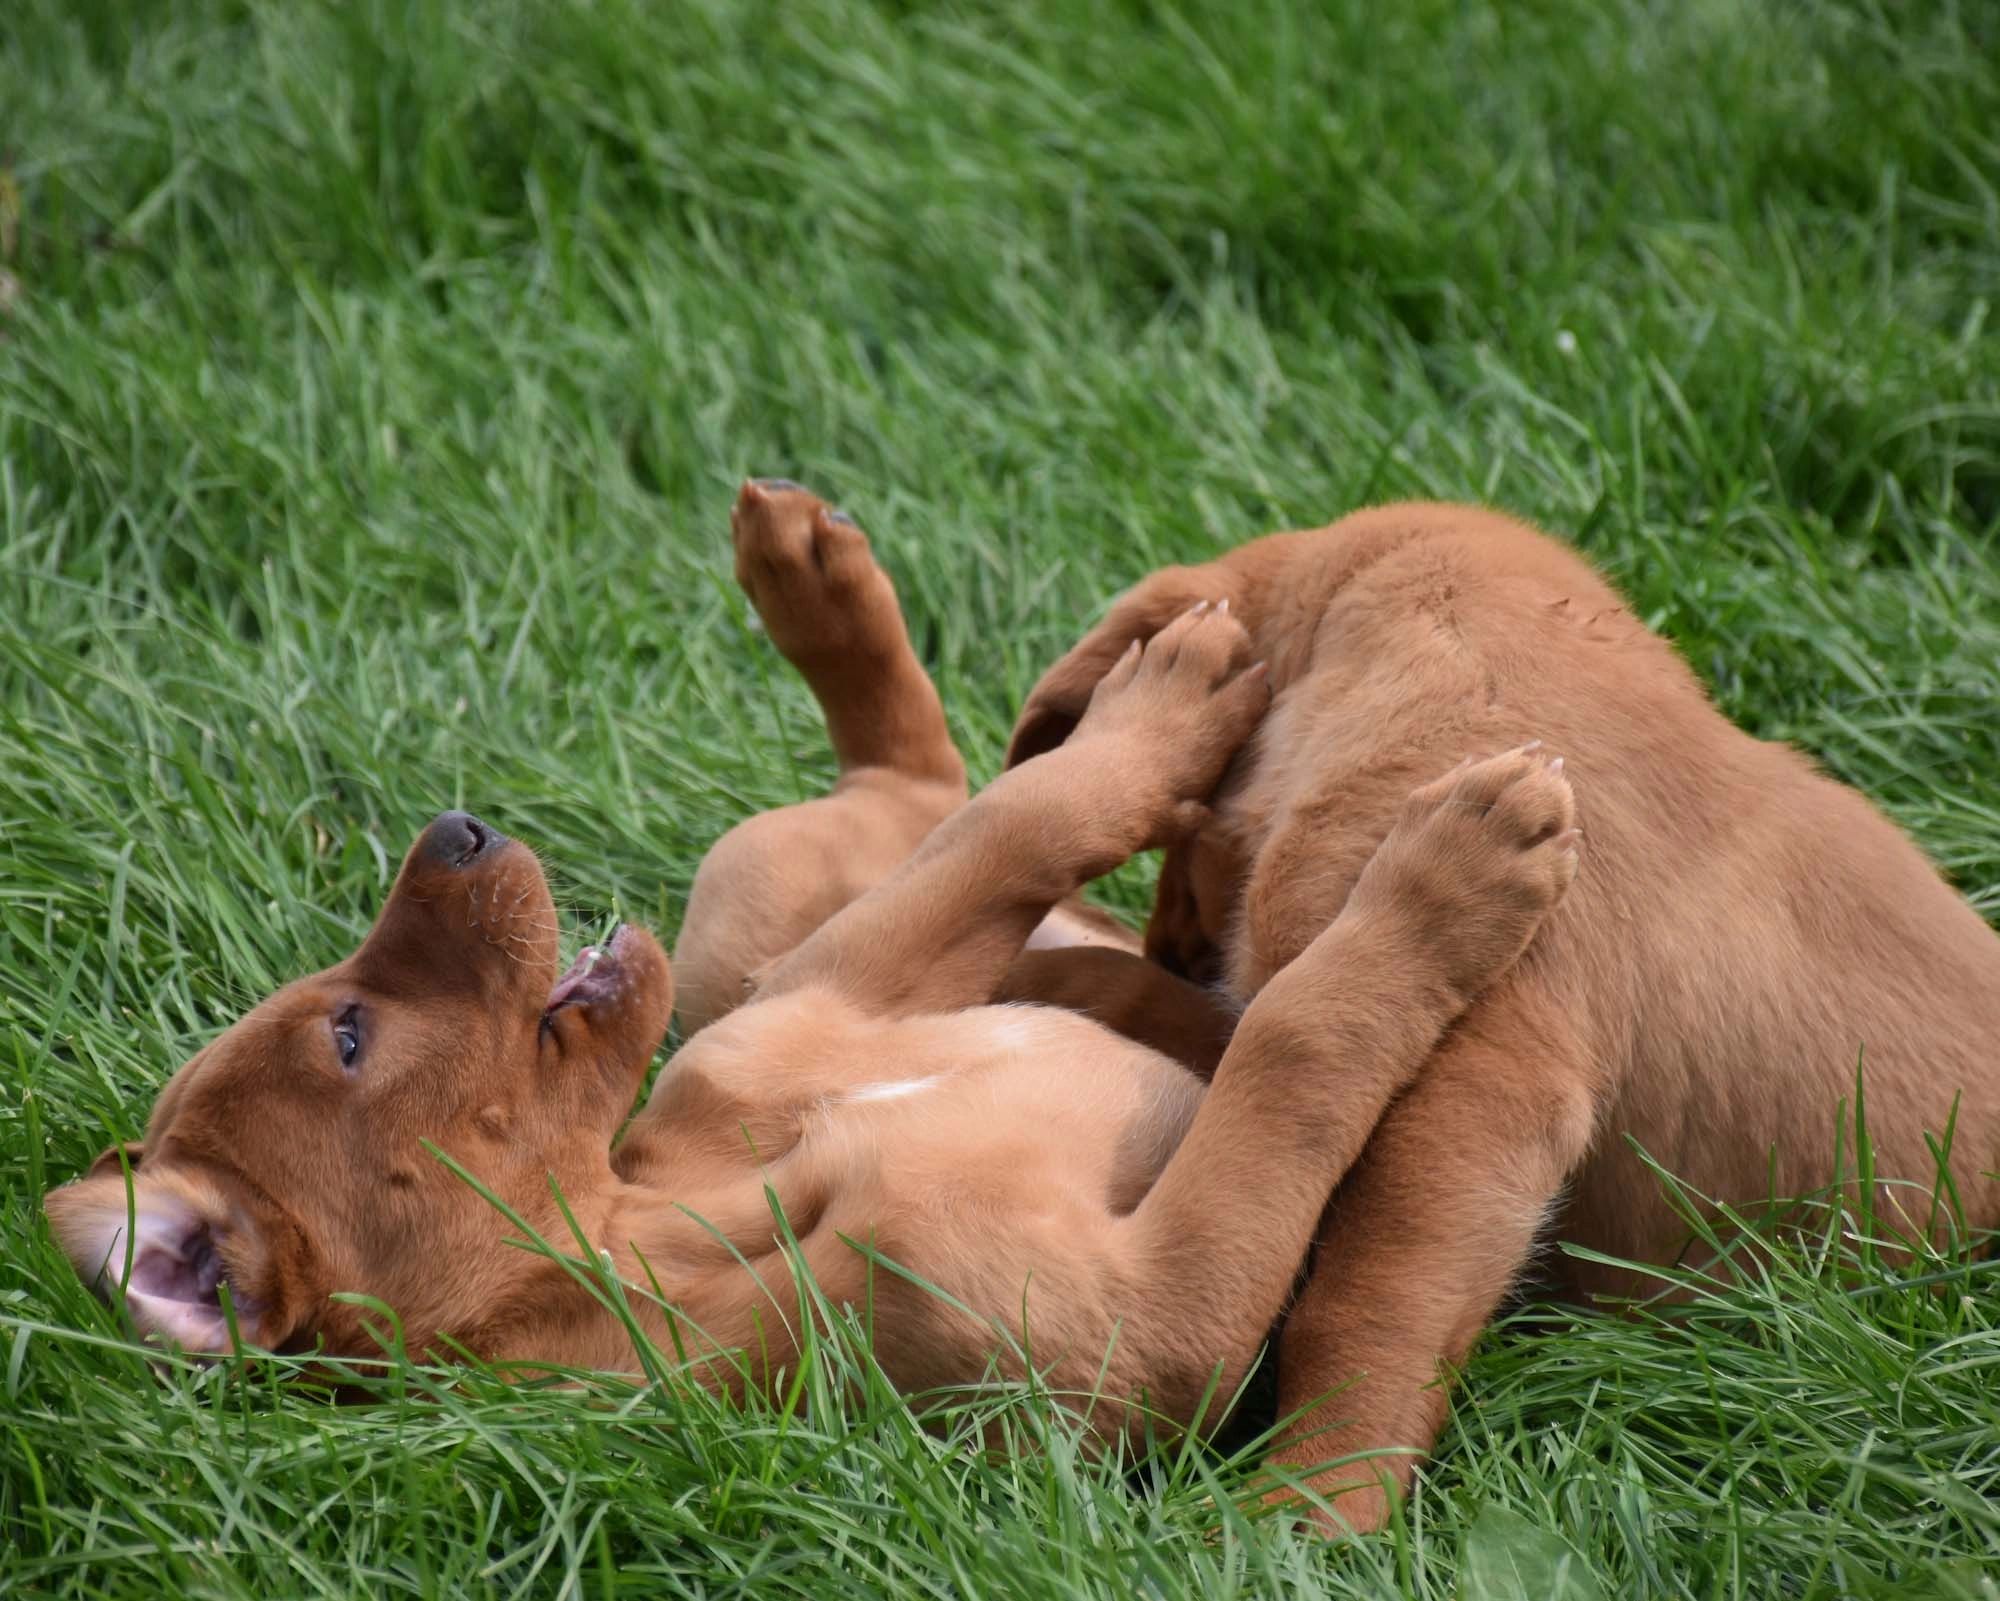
<box><xmin>46</xmin><ymin>813</ymin><xmax>674</xmax><ymax>1355</ymax></box>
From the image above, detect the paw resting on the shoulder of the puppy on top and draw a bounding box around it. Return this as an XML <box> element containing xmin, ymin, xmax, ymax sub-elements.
<box><xmin>1348</xmin><ymin>740</ymin><xmax>1582</xmax><ymax>1001</ymax></box>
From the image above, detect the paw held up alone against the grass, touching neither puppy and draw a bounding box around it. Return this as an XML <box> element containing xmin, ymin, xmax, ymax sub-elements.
<box><xmin>730</xmin><ymin>478</ymin><xmax>908</xmax><ymax>666</ymax></box>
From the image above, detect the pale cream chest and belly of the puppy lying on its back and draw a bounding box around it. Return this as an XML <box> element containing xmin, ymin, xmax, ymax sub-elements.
<box><xmin>614</xmin><ymin>991</ymin><xmax>1202</xmax><ymax>1389</ymax></box>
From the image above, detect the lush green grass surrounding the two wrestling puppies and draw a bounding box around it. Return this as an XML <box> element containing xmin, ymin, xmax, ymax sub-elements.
<box><xmin>0</xmin><ymin>0</ymin><xmax>2000</xmax><ymax>1597</ymax></box>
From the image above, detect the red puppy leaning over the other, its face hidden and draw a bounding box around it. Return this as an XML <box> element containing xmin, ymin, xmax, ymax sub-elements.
<box><xmin>1010</xmin><ymin>504</ymin><xmax>2000</xmax><ymax>1527</ymax></box>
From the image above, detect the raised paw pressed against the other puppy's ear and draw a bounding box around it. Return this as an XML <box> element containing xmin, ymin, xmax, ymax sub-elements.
<box><xmin>1070</xmin><ymin>600</ymin><xmax>1270</xmax><ymax>845</ymax></box>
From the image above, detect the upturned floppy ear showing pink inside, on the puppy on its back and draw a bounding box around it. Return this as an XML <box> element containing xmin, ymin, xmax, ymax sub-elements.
<box><xmin>42</xmin><ymin>1145</ymin><xmax>282</xmax><ymax>1355</ymax></box>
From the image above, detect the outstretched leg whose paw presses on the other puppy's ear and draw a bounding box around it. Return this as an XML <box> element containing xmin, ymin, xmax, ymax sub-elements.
<box><xmin>756</xmin><ymin>604</ymin><xmax>1270</xmax><ymax>1015</ymax></box>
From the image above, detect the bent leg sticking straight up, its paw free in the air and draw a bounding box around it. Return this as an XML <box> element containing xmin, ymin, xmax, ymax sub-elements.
<box><xmin>674</xmin><ymin>478</ymin><xmax>966</xmax><ymax>1037</ymax></box>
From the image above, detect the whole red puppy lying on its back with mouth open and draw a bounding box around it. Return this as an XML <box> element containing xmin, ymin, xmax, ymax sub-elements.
<box><xmin>48</xmin><ymin>486</ymin><xmax>1576</xmax><ymax>1472</ymax></box>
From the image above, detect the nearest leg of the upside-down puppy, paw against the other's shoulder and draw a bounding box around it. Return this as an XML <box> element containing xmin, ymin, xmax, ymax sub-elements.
<box><xmin>1084</xmin><ymin>750</ymin><xmax>1578</xmax><ymax>1445</ymax></box>
